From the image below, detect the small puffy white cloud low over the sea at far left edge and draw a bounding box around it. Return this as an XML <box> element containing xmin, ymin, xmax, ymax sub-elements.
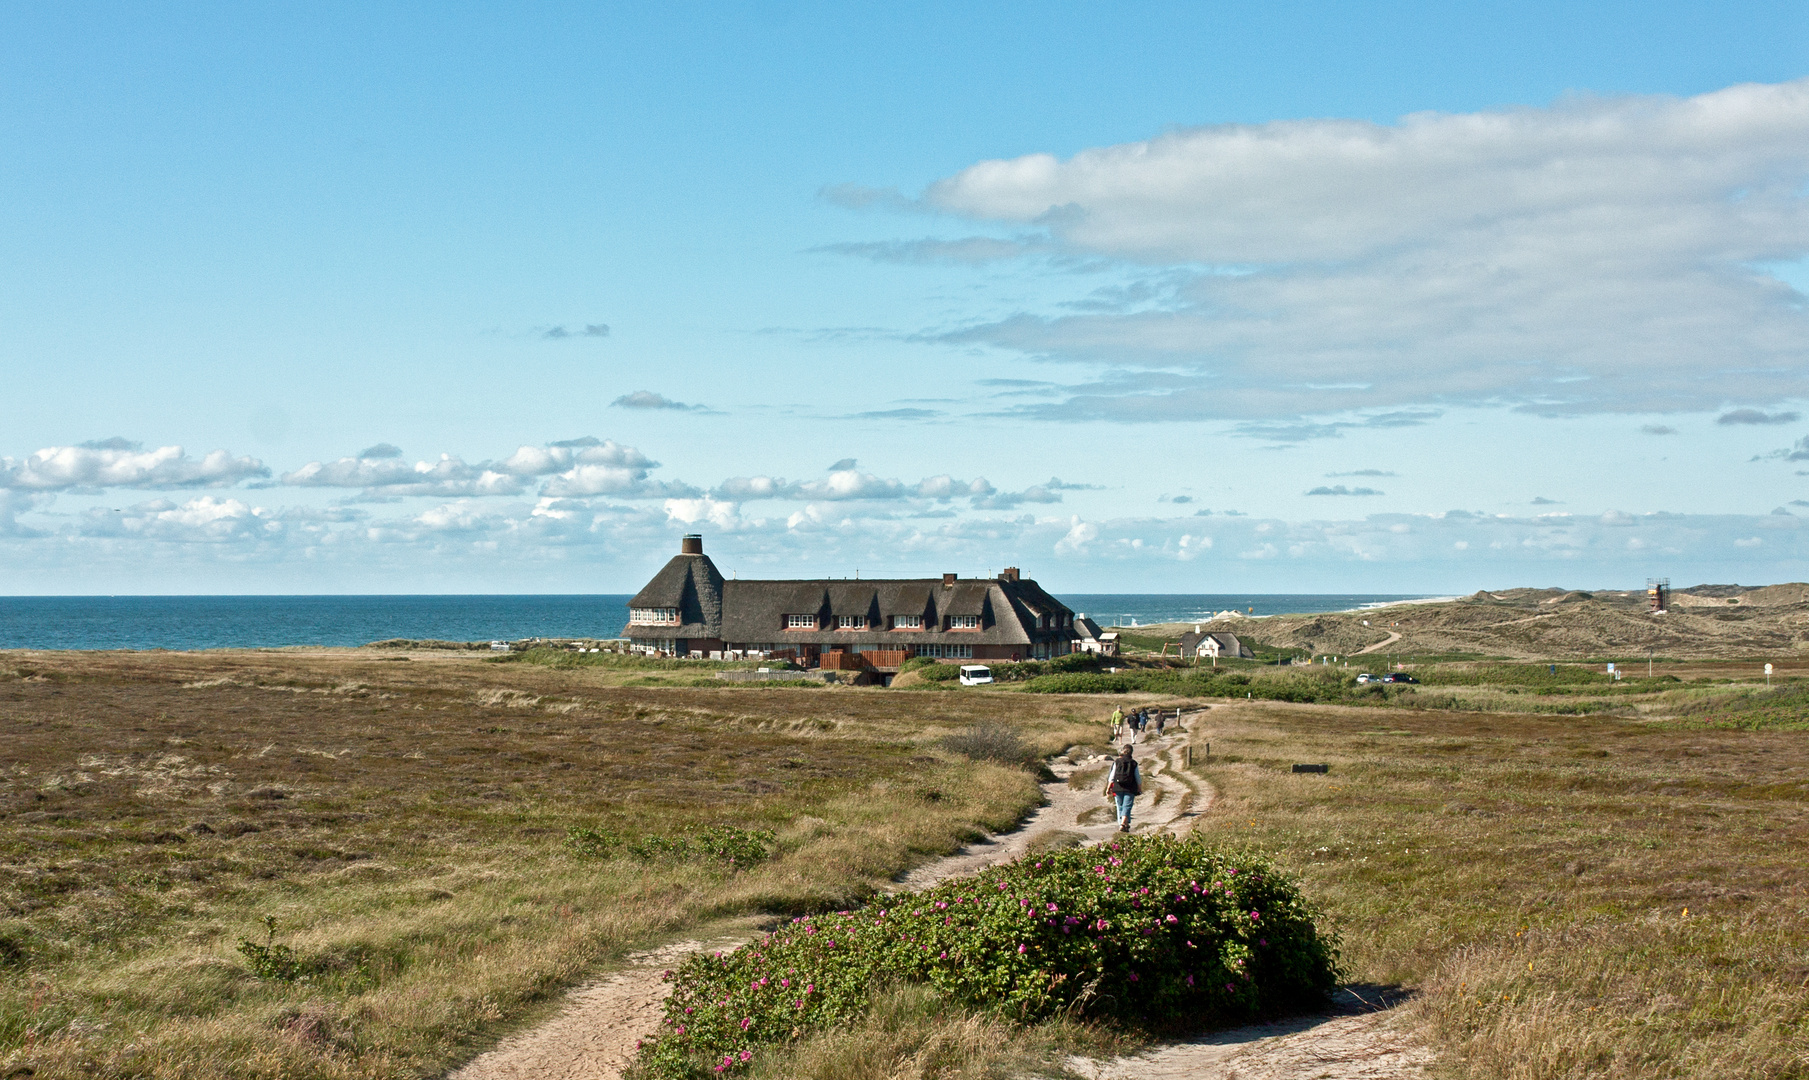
<box><xmin>0</xmin><ymin>438</ymin><xmax>270</xmax><ymax>492</ymax></box>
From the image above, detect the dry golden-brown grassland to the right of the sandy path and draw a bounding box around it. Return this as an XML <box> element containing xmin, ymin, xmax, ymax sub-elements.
<box><xmin>1192</xmin><ymin>704</ymin><xmax>1809</xmax><ymax>1080</ymax></box>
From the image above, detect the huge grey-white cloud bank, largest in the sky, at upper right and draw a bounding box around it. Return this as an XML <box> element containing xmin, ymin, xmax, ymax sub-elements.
<box><xmin>924</xmin><ymin>81</ymin><xmax>1809</xmax><ymax>420</ymax></box>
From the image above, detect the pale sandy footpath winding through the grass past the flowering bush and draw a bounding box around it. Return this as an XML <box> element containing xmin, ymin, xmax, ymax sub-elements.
<box><xmin>449</xmin><ymin>713</ymin><xmax>1418</xmax><ymax>1080</ymax></box>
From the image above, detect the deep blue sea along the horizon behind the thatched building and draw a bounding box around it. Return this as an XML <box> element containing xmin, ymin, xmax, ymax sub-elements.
<box><xmin>0</xmin><ymin>593</ymin><xmax>1418</xmax><ymax>649</ymax></box>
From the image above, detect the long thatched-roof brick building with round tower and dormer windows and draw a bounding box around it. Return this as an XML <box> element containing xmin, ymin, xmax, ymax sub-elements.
<box><xmin>622</xmin><ymin>535</ymin><xmax>1075</xmax><ymax>668</ymax></box>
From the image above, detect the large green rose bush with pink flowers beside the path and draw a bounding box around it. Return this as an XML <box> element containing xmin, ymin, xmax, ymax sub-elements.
<box><xmin>639</xmin><ymin>836</ymin><xmax>1339</xmax><ymax>1080</ymax></box>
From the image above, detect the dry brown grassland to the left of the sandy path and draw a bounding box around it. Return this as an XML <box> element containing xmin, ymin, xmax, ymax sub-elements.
<box><xmin>0</xmin><ymin>651</ymin><xmax>1084</xmax><ymax>1078</ymax></box>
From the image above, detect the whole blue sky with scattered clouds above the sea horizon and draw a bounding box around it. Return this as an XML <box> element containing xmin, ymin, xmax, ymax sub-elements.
<box><xmin>0</xmin><ymin>4</ymin><xmax>1809</xmax><ymax>593</ymax></box>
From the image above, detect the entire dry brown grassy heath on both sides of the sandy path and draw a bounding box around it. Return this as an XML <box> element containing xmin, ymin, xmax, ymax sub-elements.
<box><xmin>0</xmin><ymin>649</ymin><xmax>1809</xmax><ymax>1080</ymax></box>
